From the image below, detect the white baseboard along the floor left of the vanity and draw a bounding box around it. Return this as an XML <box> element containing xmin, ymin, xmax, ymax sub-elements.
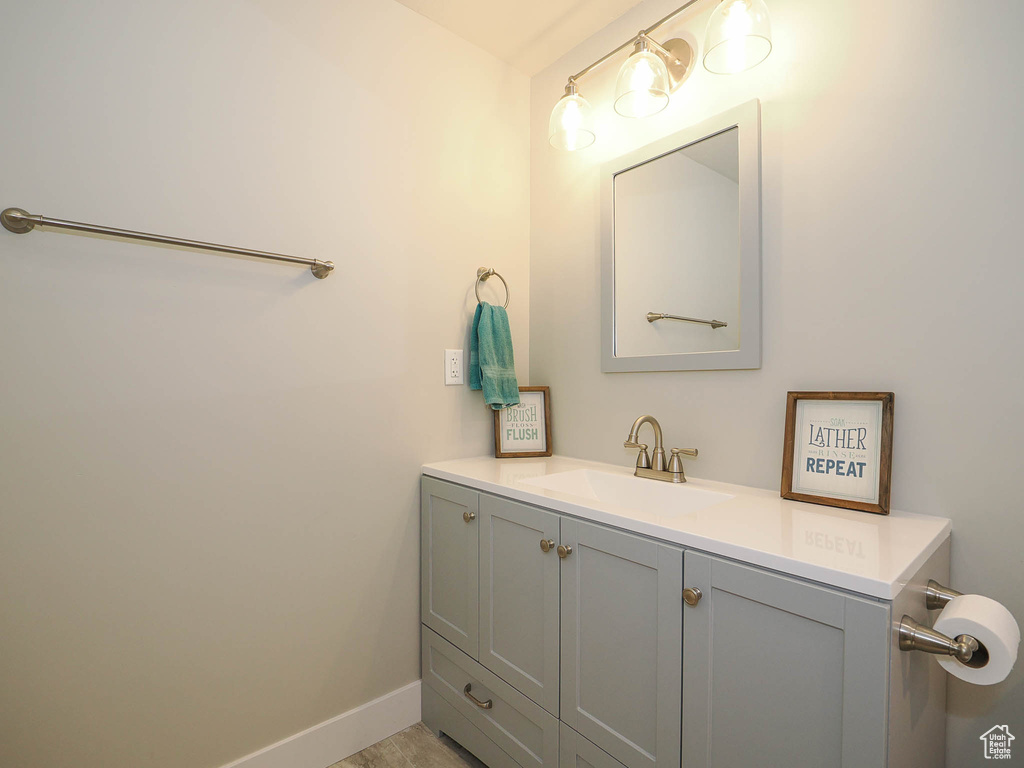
<box><xmin>221</xmin><ymin>680</ymin><xmax>420</xmax><ymax>768</ymax></box>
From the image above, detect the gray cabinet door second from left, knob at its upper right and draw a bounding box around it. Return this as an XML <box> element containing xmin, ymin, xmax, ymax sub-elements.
<box><xmin>479</xmin><ymin>496</ymin><xmax>558</xmax><ymax>717</ymax></box>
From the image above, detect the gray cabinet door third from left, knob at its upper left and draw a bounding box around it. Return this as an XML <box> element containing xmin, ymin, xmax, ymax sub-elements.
<box><xmin>561</xmin><ymin>518</ymin><xmax>683</xmax><ymax>768</ymax></box>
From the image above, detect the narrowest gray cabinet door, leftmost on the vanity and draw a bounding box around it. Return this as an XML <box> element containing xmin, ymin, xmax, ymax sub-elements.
<box><xmin>420</xmin><ymin>477</ymin><xmax>479</xmax><ymax>658</ymax></box>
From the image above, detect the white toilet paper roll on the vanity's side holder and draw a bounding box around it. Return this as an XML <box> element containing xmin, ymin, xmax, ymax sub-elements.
<box><xmin>934</xmin><ymin>595</ymin><xmax>1021</xmax><ymax>685</ymax></box>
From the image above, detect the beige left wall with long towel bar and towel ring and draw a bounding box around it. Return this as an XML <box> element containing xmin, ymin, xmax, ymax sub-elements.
<box><xmin>0</xmin><ymin>0</ymin><xmax>528</xmax><ymax>768</ymax></box>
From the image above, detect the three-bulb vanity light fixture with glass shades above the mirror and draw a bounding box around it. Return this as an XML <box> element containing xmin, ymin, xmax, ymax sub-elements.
<box><xmin>548</xmin><ymin>0</ymin><xmax>771</xmax><ymax>152</ymax></box>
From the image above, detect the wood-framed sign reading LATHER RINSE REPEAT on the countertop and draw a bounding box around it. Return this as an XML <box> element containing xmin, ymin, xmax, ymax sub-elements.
<box><xmin>782</xmin><ymin>392</ymin><xmax>893</xmax><ymax>515</ymax></box>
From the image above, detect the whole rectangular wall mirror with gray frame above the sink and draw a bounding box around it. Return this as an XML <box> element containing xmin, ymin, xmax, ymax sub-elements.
<box><xmin>601</xmin><ymin>100</ymin><xmax>761</xmax><ymax>372</ymax></box>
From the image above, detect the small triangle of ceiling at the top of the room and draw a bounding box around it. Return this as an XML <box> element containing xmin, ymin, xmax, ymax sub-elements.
<box><xmin>398</xmin><ymin>0</ymin><xmax>641</xmax><ymax>76</ymax></box>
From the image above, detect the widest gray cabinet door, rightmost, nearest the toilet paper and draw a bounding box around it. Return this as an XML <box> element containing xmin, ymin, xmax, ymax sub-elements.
<box><xmin>683</xmin><ymin>551</ymin><xmax>890</xmax><ymax>768</ymax></box>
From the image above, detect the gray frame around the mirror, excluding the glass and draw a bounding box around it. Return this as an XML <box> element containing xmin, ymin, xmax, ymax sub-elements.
<box><xmin>601</xmin><ymin>99</ymin><xmax>761</xmax><ymax>373</ymax></box>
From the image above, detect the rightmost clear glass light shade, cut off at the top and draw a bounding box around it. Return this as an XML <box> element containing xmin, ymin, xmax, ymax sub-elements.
<box><xmin>705</xmin><ymin>0</ymin><xmax>771</xmax><ymax>75</ymax></box>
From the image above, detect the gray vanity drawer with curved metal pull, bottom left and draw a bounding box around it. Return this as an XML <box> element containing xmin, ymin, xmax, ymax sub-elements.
<box><xmin>422</xmin><ymin>627</ymin><xmax>558</xmax><ymax>768</ymax></box>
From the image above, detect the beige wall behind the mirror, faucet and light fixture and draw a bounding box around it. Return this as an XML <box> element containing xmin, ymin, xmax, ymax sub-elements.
<box><xmin>530</xmin><ymin>0</ymin><xmax>1024</xmax><ymax>768</ymax></box>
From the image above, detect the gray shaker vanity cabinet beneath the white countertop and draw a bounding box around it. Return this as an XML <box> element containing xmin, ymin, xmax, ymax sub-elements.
<box><xmin>421</xmin><ymin>476</ymin><xmax>949</xmax><ymax>768</ymax></box>
